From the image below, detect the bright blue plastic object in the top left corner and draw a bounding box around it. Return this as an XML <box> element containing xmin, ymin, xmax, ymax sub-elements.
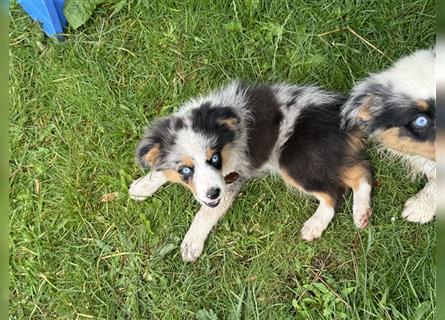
<box><xmin>18</xmin><ymin>0</ymin><xmax>67</xmax><ymax>39</ymax></box>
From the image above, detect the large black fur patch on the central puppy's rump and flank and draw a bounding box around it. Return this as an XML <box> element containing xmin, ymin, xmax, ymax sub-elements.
<box><xmin>279</xmin><ymin>96</ymin><xmax>352</xmax><ymax>200</ymax></box>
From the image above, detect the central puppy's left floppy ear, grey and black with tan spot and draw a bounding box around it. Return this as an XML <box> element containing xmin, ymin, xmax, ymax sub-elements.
<box><xmin>136</xmin><ymin>118</ymin><xmax>172</xmax><ymax>169</ymax></box>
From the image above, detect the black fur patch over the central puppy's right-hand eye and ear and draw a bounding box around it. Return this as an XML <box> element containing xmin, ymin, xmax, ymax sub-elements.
<box><xmin>192</xmin><ymin>102</ymin><xmax>240</xmax><ymax>150</ymax></box>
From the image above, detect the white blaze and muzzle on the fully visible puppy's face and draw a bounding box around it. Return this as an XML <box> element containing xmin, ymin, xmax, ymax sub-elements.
<box><xmin>176</xmin><ymin>129</ymin><xmax>225</xmax><ymax>204</ymax></box>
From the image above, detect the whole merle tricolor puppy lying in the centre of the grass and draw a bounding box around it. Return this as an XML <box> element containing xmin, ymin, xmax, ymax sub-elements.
<box><xmin>129</xmin><ymin>83</ymin><xmax>371</xmax><ymax>261</ymax></box>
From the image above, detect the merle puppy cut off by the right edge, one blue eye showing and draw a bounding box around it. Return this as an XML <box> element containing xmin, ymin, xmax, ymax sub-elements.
<box><xmin>342</xmin><ymin>50</ymin><xmax>436</xmax><ymax>223</ymax></box>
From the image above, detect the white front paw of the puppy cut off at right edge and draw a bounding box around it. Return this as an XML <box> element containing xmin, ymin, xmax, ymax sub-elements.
<box><xmin>402</xmin><ymin>179</ymin><xmax>436</xmax><ymax>223</ymax></box>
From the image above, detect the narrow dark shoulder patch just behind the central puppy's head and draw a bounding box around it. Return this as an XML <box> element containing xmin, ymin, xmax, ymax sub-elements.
<box><xmin>245</xmin><ymin>86</ymin><xmax>283</xmax><ymax>168</ymax></box>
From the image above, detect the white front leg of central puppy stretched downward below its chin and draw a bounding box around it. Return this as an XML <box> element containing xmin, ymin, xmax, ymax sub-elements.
<box><xmin>181</xmin><ymin>185</ymin><xmax>239</xmax><ymax>261</ymax></box>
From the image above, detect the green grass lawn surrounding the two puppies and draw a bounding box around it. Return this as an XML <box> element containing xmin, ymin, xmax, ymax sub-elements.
<box><xmin>9</xmin><ymin>0</ymin><xmax>435</xmax><ymax>320</ymax></box>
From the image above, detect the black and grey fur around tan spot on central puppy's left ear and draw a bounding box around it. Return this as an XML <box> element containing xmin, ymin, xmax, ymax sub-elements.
<box><xmin>136</xmin><ymin>118</ymin><xmax>176</xmax><ymax>169</ymax></box>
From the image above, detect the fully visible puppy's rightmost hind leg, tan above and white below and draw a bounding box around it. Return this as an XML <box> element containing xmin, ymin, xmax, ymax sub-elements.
<box><xmin>343</xmin><ymin>162</ymin><xmax>372</xmax><ymax>229</ymax></box>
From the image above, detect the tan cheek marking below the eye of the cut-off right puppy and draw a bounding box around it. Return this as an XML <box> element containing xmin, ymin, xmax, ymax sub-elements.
<box><xmin>377</xmin><ymin>128</ymin><xmax>436</xmax><ymax>160</ymax></box>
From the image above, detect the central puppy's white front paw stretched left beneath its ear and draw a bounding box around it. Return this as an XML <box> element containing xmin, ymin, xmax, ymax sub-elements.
<box><xmin>128</xmin><ymin>171</ymin><xmax>167</xmax><ymax>201</ymax></box>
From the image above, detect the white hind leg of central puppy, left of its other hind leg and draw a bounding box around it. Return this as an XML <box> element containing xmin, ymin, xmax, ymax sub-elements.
<box><xmin>301</xmin><ymin>192</ymin><xmax>336</xmax><ymax>241</ymax></box>
